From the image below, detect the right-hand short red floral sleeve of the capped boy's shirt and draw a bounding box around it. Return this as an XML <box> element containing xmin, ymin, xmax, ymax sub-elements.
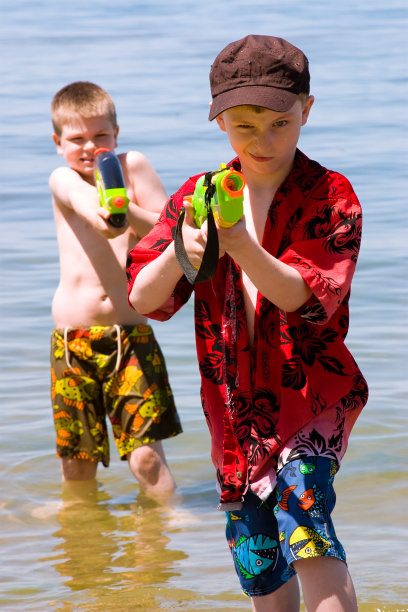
<box><xmin>280</xmin><ymin>173</ymin><xmax>362</xmax><ymax>324</ymax></box>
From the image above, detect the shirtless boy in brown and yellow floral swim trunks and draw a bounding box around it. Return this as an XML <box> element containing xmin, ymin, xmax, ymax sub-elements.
<box><xmin>49</xmin><ymin>82</ymin><xmax>181</xmax><ymax>496</ymax></box>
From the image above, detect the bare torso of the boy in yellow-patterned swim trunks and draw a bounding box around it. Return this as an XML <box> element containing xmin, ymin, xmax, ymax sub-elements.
<box><xmin>52</xmin><ymin>182</ymin><xmax>146</xmax><ymax>327</ymax></box>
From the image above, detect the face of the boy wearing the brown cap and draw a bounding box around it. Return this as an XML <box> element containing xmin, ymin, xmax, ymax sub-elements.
<box><xmin>216</xmin><ymin>96</ymin><xmax>314</xmax><ymax>177</ymax></box>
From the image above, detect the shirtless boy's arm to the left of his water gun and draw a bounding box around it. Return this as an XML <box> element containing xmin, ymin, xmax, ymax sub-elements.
<box><xmin>49</xmin><ymin>167</ymin><xmax>127</xmax><ymax>239</ymax></box>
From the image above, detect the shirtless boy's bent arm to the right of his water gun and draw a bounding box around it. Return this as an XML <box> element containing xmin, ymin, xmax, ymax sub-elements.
<box><xmin>119</xmin><ymin>151</ymin><xmax>167</xmax><ymax>237</ymax></box>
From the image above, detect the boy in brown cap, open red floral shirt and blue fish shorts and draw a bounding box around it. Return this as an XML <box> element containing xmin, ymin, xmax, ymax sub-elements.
<box><xmin>128</xmin><ymin>35</ymin><xmax>368</xmax><ymax>612</ymax></box>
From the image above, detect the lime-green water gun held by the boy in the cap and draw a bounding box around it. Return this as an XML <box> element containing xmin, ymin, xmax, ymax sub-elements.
<box><xmin>190</xmin><ymin>164</ymin><xmax>245</xmax><ymax>227</ymax></box>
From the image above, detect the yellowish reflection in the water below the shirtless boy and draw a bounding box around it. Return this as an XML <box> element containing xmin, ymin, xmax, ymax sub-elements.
<box><xmin>47</xmin><ymin>483</ymin><xmax>187</xmax><ymax>609</ymax></box>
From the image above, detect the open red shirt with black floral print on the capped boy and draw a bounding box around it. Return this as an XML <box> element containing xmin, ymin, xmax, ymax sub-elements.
<box><xmin>127</xmin><ymin>151</ymin><xmax>368</xmax><ymax>508</ymax></box>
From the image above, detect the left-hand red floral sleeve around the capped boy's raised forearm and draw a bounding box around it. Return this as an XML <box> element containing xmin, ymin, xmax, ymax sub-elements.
<box><xmin>126</xmin><ymin>177</ymin><xmax>196</xmax><ymax>321</ymax></box>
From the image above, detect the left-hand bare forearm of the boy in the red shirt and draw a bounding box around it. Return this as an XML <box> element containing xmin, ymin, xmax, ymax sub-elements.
<box><xmin>129</xmin><ymin>243</ymin><xmax>183</xmax><ymax>314</ymax></box>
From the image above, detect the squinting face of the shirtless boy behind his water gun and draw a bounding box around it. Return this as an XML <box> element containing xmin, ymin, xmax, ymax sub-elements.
<box><xmin>52</xmin><ymin>116</ymin><xmax>119</xmax><ymax>183</ymax></box>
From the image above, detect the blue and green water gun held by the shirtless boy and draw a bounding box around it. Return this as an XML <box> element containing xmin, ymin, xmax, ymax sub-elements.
<box><xmin>94</xmin><ymin>147</ymin><xmax>129</xmax><ymax>227</ymax></box>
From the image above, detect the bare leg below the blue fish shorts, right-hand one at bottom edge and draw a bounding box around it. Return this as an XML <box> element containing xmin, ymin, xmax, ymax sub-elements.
<box><xmin>293</xmin><ymin>557</ymin><xmax>358</xmax><ymax>612</ymax></box>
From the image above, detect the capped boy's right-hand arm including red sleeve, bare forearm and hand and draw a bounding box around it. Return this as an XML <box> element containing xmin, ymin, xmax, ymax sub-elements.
<box><xmin>218</xmin><ymin>173</ymin><xmax>362</xmax><ymax>323</ymax></box>
